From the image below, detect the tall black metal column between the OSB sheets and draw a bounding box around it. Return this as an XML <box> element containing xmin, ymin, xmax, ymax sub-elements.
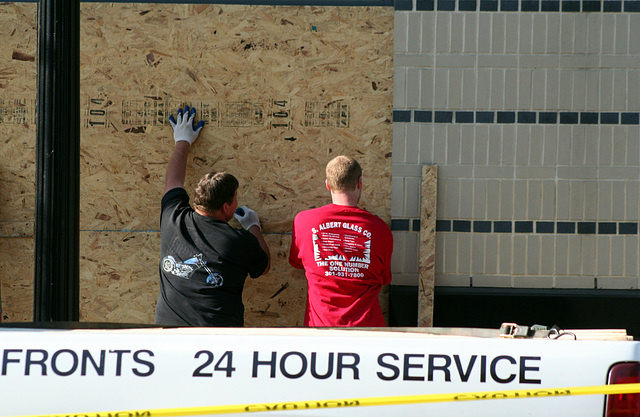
<box><xmin>33</xmin><ymin>0</ymin><xmax>80</xmax><ymax>322</ymax></box>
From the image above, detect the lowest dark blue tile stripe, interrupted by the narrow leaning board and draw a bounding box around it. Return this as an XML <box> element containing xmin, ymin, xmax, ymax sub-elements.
<box><xmin>391</xmin><ymin>219</ymin><xmax>639</xmax><ymax>235</ymax></box>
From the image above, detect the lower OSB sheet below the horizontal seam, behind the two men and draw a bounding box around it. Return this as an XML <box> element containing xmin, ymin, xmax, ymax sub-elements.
<box><xmin>80</xmin><ymin>232</ymin><xmax>306</xmax><ymax>327</ymax></box>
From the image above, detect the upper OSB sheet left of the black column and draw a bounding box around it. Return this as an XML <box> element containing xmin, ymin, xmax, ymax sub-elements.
<box><xmin>0</xmin><ymin>4</ymin><xmax>37</xmax><ymax>231</ymax></box>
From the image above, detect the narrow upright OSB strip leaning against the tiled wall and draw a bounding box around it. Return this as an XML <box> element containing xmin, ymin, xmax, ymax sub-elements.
<box><xmin>418</xmin><ymin>165</ymin><xmax>438</xmax><ymax>327</ymax></box>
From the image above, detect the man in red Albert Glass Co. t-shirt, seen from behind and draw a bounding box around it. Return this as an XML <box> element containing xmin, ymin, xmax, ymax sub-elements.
<box><xmin>289</xmin><ymin>156</ymin><xmax>393</xmax><ymax>327</ymax></box>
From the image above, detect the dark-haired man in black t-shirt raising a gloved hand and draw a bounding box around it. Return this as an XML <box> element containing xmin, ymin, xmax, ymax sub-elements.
<box><xmin>155</xmin><ymin>106</ymin><xmax>271</xmax><ymax>327</ymax></box>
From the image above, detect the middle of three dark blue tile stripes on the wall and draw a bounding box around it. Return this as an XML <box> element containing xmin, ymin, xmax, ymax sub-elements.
<box><xmin>393</xmin><ymin>109</ymin><xmax>640</xmax><ymax>125</ymax></box>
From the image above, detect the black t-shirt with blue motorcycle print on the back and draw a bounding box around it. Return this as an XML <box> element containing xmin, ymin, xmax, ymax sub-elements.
<box><xmin>155</xmin><ymin>188</ymin><xmax>268</xmax><ymax>327</ymax></box>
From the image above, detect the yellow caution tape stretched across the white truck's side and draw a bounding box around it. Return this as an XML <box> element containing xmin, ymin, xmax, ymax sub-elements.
<box><xmin>8</xmin><ymin>384</ymin><xmax>640</xmax><ymax>417</ymax></box>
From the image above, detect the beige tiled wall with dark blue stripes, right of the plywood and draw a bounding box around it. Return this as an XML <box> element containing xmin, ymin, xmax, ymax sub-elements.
<box><xmin>392</xmin><ymin>0</ymin><xmax>640</xmax><ymax>289</ymax></box>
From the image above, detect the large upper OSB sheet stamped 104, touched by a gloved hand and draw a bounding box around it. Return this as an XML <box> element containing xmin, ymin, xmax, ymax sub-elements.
<box><xmin>81</xmin><ymin>4</ymin><xmax>393</xmax><ymax>233</ymax></box>
